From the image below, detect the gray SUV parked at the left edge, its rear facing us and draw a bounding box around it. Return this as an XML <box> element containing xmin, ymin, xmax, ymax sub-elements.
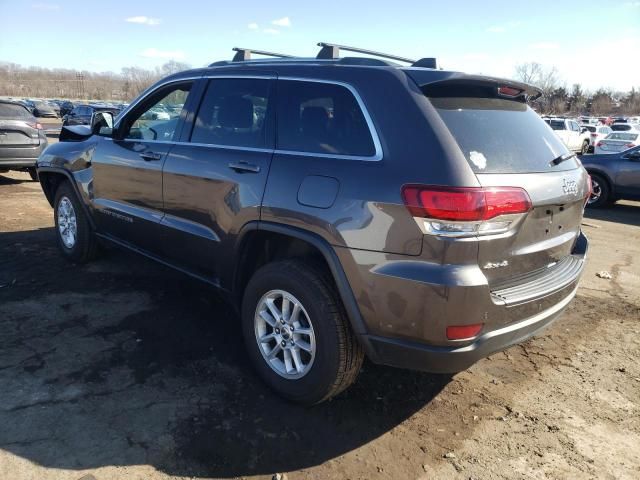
<box><xmin>0</xmin><ymin>100</ymin><xmax>47</xmax><ymax>180</ymax></box>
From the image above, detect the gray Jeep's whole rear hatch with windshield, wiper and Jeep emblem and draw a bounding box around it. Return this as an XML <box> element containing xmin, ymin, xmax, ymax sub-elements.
<box><xmin>408</xmin><ymin>73</ymin><xmax>589</xmax><ymax>288</ymax></box>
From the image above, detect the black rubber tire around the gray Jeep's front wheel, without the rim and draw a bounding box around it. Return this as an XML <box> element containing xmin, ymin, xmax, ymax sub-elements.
<box><xmin>53</xmin><ymin>181</ymin><xmax>98</xmax><ymax>263</ymax></box>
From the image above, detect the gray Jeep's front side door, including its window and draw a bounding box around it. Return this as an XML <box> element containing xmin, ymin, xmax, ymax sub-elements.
<box><xmin>92</xmin><ymin>81</ymin><xmax>193</xmax><ymax>253</ymax></box>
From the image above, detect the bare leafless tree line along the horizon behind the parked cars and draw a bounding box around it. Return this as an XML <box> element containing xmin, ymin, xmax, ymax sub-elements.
<box><xmin>0</xmin><ymin>61</ymin><xmax>640</xmax><ymax>115</ymax></box>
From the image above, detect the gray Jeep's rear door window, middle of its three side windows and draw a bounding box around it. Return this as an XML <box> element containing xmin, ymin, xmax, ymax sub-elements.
<box><xmin>191</xmin><ymin>78</ymin><xmax>272</xmax><ymax>148</ymax></box>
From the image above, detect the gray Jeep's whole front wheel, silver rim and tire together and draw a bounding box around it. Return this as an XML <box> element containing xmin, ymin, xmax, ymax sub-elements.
<box><xmin>53</xmin><ymin>182</ymin><xmax>98</xmax><ymax>263</ymax></box>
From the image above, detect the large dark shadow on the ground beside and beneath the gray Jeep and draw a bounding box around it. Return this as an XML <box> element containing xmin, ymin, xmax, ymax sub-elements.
<box><xmin>0</xmin><ymin>228</ymin><xmax>450</xmax><ymax>477</ymax></box>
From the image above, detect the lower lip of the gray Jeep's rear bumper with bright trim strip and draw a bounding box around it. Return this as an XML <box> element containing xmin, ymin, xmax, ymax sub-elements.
<box><xmin>362</xmin><ymin>286</ymin><xmax>577</xmax><ymax>373</ymax></box>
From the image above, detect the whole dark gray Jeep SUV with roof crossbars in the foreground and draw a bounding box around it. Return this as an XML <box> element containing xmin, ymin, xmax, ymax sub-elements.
<box><xmin>38</xmin><ymin>44</ymin><xmax>589</xmax><ymax>404</ymax></box>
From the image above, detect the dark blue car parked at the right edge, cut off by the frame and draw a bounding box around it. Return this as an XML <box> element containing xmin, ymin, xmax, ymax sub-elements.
<box><xmin>582</xmin><ymin>146</ymin><xmax>640</xmax><ymax>208</ymax></box>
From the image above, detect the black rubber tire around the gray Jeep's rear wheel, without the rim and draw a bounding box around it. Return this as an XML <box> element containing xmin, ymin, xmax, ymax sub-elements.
<box><xmin>242</xmin><ymin>260</ymin><xmax>364</xmax><ymax>405</ymax></box>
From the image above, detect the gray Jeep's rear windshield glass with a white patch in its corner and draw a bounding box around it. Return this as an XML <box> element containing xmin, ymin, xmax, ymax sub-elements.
<box><xmin>430</xmin><ymin>97</ymin><xmax>578</xmax><ymax>173</ymax></box>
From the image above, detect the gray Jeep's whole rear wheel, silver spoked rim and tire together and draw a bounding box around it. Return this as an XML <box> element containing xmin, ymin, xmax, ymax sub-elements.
<box><xmin>242</xmin><ymin>260</ymin><xmax>364</xmax><ymax>405</ymax></box>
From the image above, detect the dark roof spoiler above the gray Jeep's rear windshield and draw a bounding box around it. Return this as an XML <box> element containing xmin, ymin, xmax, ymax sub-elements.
<box><xmin>404</xmin><ymin>68</ymin><xmax>542</xmax><ymax>102</ymax></box>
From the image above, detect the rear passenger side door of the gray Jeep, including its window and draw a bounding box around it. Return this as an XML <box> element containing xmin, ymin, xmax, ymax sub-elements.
<box><xmin>162</xmin><ymin>75</ymin><xmax>275</xmax><ymax>281</ymax></box>
